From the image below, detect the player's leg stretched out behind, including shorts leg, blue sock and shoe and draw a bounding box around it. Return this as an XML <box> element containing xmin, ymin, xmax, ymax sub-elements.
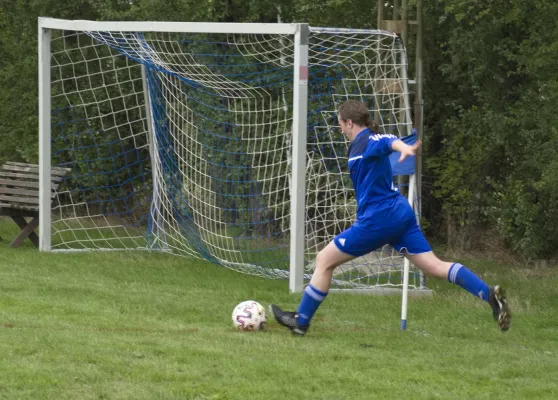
<box><xmin>392</xmin><ymin>222</ymin><xmax>511</xmax><ymax>331</ymax></box>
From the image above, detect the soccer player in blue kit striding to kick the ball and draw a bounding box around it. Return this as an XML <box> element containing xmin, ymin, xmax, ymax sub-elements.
<box><xmin>270</xmin><ymin>100</ymin><xmax>511</xmax><ymax>335</ymax></box>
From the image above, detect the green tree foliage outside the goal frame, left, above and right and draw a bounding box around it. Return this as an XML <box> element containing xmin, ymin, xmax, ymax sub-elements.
<box><xmin>0</xmin><ymin>0</ymin><xmax>558</xmax><ymax>258</ymax></box>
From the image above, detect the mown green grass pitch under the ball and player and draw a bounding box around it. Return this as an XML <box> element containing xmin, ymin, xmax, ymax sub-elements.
<box><xmin>0</xmin><ymin>219</ymin><xmax>558</xmax><ymax>399</ymax></box>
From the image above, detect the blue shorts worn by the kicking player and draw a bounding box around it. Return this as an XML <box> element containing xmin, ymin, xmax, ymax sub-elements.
<box><xmin>333</xmin><ymin>218</ymin><xmax>432</xmax><ymax>257</ymax></box>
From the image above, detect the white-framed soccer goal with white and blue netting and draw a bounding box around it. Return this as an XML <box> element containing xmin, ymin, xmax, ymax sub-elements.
<box><xmin>39</xmin><ymin>18</ymin><xmax>427</xmax><ymax>302</ymax></box>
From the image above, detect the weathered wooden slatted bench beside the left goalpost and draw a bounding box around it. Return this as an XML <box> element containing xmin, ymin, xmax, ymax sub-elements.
<box><xmin>0</xmin><ymin>162</ymin><xmax>70</xmax><ymax>247</ymax></box>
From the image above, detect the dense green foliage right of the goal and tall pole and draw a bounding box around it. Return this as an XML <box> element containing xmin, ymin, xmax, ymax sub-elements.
<box><xmin>425</xmin><ymin>0</ymin><xmax>558</xmax><ymax>258</ymax></box>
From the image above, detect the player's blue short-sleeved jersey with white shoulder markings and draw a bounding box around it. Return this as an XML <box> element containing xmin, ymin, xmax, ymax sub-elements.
<box><xmin>349</xmin><ymin>129</ymin><xmax>414</xmax><ymax>225</ymax></box>
